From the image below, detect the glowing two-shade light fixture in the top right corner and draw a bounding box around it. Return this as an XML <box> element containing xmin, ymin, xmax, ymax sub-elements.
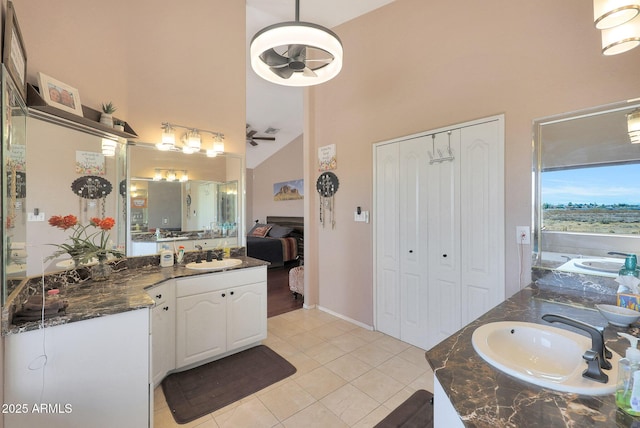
<box><xmin>593</xmin><ymin>0</ymin><xmax>640</xmax><ymax>55</ymax></box>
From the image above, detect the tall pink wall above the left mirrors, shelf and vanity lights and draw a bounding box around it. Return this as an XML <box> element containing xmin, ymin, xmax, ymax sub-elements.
<box><xmin>14</xmin><ymin>0</ymin><xmax>246</xmax><ymax>154</ymax></box>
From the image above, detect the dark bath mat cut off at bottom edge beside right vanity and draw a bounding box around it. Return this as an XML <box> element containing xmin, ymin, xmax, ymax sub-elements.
<box><xmin>374</xmin><ymin>389</ymin><xmax>433</xmax><ymax>428</ymax></box>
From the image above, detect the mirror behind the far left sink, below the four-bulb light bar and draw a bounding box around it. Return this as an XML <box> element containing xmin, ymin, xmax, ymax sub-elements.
<box><xmin>127</xmin><ymin>143</ymin><xmax>244</xmax><ymax>256</ymax></box>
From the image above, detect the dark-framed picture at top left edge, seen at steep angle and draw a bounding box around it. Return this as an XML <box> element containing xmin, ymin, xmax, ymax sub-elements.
<box><xmin>2</xmin><ymin>1</ymin><xmax>27</xmax><ymax>100</ymax></box>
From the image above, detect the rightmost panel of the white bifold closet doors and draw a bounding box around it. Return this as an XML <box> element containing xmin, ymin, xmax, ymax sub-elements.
<box><xmin>460</xmin><ymin>120</ymin><xmax>504</xmax><ymax>323</ymax></box>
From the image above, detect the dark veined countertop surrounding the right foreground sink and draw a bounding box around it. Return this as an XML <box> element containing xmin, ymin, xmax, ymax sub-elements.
<box><xmin>426</xmin><ymin>276</ymin><xmax>640</xmax><ymax>428</ymax></box>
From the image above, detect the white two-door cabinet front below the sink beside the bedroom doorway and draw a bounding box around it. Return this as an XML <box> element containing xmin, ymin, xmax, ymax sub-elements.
<box><xmin>175</xmin><ymin>266</ymin><xmax>267</xmax><ymax>369</ymax></box>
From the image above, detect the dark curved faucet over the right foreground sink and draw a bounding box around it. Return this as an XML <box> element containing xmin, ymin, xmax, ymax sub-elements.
<box><xmin>542</xmin><ymin>314</ymin><xmax>613</xmax><ymax>383</ymax></box>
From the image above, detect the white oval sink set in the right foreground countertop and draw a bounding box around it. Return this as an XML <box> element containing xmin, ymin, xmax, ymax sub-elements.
<box><xmin>471</xmin><ymin>321</ymin><xmax>620</xmax><ymax>395</ymax></box>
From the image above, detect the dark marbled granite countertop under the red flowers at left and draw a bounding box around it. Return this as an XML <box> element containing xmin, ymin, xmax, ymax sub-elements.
<box><xmin>2</xmin><ymin>254</ymin><xmax>269</xmax><ymax>336</ymax></box>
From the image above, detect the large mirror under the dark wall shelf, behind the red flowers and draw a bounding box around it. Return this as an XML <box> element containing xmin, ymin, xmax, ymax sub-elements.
<box><xmin>2</xmin><ymin>82</ymin><xmax>127</xmax><ymax>303</ymax></box>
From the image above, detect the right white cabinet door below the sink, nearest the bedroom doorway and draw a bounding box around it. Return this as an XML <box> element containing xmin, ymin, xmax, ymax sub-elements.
<box><xmin>227</xmin><ymin>282</ymin><xmax>267</xmax><ymax>350</ymax></box>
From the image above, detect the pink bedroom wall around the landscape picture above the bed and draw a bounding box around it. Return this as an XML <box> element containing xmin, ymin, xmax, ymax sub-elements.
<box><xmin>247</xmin><ymin>136</ymin><xmax>304</xmax><ymax>224</ymax></box>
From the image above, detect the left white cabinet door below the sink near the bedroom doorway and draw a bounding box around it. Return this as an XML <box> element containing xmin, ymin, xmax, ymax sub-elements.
<box><xmin>176</xmin><ymin>290</ymin><xmax>227</xmax><ymax>368</ymax></box>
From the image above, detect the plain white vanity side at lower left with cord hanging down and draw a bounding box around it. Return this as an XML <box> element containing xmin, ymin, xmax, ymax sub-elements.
<box><xmin>3</xmin><ymin>308</ymin><xmax>153</xmax><ymax>428</ymax></box>
